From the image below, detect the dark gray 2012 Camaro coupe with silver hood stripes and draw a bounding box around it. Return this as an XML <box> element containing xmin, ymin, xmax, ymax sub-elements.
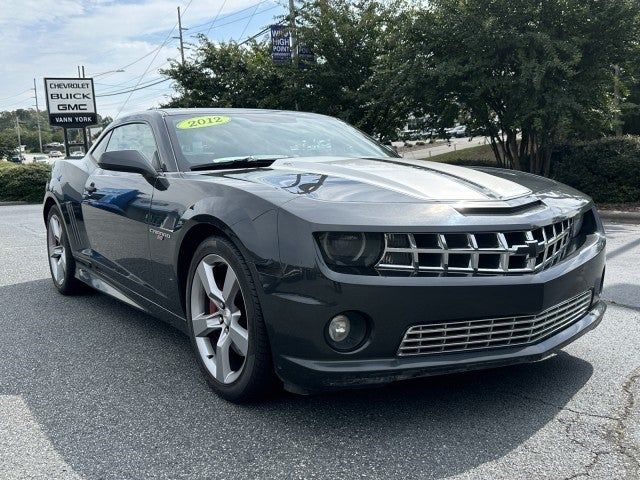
<box><xmin>44</xmin><ymin>109</ymin><xmax>605</xmax><ymax>401</ymax></box>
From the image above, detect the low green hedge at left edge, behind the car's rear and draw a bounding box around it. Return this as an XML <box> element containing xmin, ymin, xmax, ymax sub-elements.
<box><xmin>0</xmin><ymin>161</ymin><xmax>51</xmax><ymax>202</ymax></box>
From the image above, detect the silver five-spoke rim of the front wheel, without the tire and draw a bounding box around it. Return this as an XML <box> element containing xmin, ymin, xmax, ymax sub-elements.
<box><xmin>190</xmin><ymin>254</ymin><xmax>249</xmax><ymax>384</ymax></box>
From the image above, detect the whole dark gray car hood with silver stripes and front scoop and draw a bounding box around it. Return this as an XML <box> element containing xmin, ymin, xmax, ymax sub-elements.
<box><xmin>187</xmin><ymin>157</ymin><xmax>590</xmax><ymax>229</ymax></box>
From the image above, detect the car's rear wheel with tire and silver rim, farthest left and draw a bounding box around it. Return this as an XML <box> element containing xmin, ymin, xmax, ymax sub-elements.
<box><xmin>47</xmin><ymin>206</ymin><xmax>87</xmax><ymax>295</ymax></box>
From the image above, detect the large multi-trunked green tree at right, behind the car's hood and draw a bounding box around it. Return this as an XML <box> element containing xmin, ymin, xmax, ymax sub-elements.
<box><xmin>396</xmin><ymin>0</ymin><xmax>640</xmax><ymax>174</ymax></box>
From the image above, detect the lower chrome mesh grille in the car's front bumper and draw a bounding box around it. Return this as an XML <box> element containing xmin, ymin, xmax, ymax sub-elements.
<box><xmin>398</xmin><ymin>291</ymin><xmax>591</xmax><ymax>356</ymax></box>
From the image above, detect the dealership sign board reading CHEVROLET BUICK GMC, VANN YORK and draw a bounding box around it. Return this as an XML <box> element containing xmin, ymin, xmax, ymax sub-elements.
<box><xmin>44</xmin><ymin>78</ymin><xmax>98</xmax><ymax>128</ymax></box>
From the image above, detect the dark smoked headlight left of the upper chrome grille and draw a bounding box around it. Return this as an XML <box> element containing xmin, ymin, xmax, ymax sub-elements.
<box><xmin>317</xmin><ymin>232</ymin><xmax>384</xmax><ymax>267</ymax></box>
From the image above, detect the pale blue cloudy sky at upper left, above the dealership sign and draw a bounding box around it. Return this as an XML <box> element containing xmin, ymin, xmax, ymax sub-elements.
<box><xmin>0</xmin><ymin>0</ymin><xmax>285</xmax><ymax>117</ymax></box>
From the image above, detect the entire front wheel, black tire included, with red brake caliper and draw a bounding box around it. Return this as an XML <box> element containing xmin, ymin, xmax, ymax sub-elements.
<box><xmin>185</xmin><ymin>237</ymin><xmax>275</xmax><ymax>402</ymax></box>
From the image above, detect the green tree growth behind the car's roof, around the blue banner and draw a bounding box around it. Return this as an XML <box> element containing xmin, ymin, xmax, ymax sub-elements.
<box><xmin>163</xmin><ymin>0</ymin><xmax>406</xmax><ymax>137</ymax></box>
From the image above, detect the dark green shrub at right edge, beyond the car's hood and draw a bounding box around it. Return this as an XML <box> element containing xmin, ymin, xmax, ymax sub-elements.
<box><xmin>551</xmin><ymin>136</ymin><xmax>640</xmax><ymax>203</ymax></box>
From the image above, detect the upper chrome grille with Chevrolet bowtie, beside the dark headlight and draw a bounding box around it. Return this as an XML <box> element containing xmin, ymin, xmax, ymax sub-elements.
<box><xmin>376</xmin><ymin>219</ymin><xmax>574</xmax><ymax>275</ymax></box>
